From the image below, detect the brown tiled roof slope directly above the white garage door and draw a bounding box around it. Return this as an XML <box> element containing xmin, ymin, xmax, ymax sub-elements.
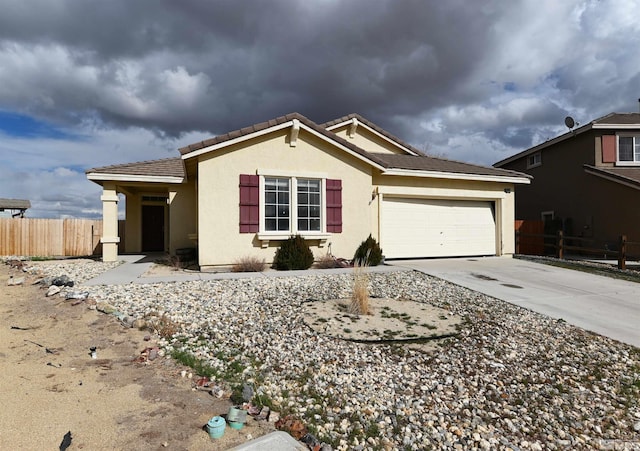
<box><xmin>376</xmin><ymin>154</ymin><xmax>531</xmax><ymax>178</ymax></box>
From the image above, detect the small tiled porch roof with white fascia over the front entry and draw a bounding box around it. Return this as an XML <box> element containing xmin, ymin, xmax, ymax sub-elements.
<box><xmin>86</xmin><ymin>157</ymin><xmax>185</xmax><ymax>183</ymax></box>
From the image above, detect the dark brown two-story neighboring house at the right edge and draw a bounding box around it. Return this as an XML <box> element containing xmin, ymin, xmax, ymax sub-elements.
<box><xmin>494</xmin><ymin>113</ymin><xmax>640</xmax><ymax>250</ymax></box>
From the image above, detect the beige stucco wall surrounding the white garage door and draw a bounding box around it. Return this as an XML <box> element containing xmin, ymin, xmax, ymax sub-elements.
<box><xmin>372</xmin><ymin>174</ymin><xmax>515</xmax><ymax>255</ymax></box>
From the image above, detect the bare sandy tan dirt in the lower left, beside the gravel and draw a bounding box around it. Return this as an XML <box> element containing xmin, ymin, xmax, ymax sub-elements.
<box><xmin>0</xmin><ymin>264</ymin><xmax>273</xmax><ymax>451</ymax></box>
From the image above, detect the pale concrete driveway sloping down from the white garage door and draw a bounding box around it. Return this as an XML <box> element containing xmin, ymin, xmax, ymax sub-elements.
<box><xmin>387</xmin><ymin>257</ymin><xmax>640</xmax><ymax>347</ymax></box>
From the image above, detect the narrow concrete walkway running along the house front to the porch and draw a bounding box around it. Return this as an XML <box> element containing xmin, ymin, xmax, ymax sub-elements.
<box><xmin>83</xmin><ymin>255</ymin><xmax>403</xmax><ymax>285</ymax></box>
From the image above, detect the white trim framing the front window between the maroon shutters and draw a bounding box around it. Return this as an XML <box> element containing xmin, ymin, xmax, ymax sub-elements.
<box><xmin>257</xmin><ymin>175</ymin><xmax>331</xmax><ymax>248</ymax></box>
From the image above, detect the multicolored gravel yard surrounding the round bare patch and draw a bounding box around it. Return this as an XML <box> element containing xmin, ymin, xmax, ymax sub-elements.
<box><xmin>21</xmin><ymin>261</ymin><xmax>640</xmax><ymax>450</ymax></box>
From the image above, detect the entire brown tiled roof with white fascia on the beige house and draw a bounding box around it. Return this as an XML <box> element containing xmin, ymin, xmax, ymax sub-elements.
<box><xmin>87</xmin><ymin>113</ymin><xmax>531</xmax><ymax>183</ymax></box>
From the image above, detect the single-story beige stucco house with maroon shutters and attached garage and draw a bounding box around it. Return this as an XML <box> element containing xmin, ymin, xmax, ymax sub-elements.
<box><xmin>87</xmin><ymin>113</ymin><xmax>530</xmax><ymax>267</ymax></box>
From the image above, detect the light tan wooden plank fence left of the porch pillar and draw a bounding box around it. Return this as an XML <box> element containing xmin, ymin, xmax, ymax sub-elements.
<box><xmin>0</xmin><ymin>218</ymin><xmax>102</xmax><ymax>257</ymax></box>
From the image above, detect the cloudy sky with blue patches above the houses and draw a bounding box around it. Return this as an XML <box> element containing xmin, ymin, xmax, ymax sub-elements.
<box><xmin>0</xmin><ymin>0</ymin><xmax>640</xmax><ymax>218</ymax></box>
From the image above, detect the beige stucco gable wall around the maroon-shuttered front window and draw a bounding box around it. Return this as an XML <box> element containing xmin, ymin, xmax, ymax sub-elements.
<box><xmin>197</xmin><ymin>129</ymin><xmax>375</xmax><ymax>267</ymax></box>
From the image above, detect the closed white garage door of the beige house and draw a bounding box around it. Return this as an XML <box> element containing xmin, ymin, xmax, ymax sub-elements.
<box><xmin>380</xmin><ymin>197</ymin><xmax>496</xmax><ymax>258</ymax></box>
